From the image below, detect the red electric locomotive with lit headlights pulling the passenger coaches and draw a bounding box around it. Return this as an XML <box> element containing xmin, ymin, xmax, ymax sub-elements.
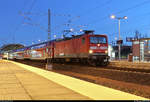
<box><xmin>53</xmin><ymin>31</ymin><xmax>109</xmax><ymax>66</ymax></box>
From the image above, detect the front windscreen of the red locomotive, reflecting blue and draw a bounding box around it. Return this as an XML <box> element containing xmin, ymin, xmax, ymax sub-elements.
<box><xmin>90</xmin><ymin>36</ymin><xmax>107</xmax><ymax>44</ymax></box>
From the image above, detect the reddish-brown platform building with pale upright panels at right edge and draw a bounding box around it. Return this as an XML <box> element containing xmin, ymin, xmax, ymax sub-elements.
<box><xmin>132</xmin><ymin>38</ymin><xmax>150</xmax><ymax>62</ymax></box>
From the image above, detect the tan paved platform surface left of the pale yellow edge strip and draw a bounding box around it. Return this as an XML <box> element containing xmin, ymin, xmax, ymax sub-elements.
<box><xmin>0</xmin><ymin>60</ymin><xmax>90</xmax><ymax>100</ymax></box>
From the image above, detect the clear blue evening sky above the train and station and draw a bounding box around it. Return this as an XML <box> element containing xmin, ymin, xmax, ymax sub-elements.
<box><xmin>0</xmin><ymin>0</ymin><xmax>150</xmax><ymax>46</ymax></box>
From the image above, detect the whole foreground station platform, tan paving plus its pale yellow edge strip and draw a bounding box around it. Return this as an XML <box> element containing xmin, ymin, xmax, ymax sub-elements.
<box><xmin>0</xmin><ymin>60</ymin><xmax>150</xmax><ymax>100</ymax></box>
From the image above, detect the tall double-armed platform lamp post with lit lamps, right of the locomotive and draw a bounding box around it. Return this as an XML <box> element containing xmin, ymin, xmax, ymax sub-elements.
<box><xmin>111</xmin><ymin>15</ymin><xmax>128</xmax><ymax>60</ymax></box>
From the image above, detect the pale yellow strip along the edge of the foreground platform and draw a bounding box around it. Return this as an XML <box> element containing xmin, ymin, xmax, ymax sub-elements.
<box><xmin>7</xmin><ymin>61</ymin><xmax>150</xmax><ymax>100</ymax></box>
